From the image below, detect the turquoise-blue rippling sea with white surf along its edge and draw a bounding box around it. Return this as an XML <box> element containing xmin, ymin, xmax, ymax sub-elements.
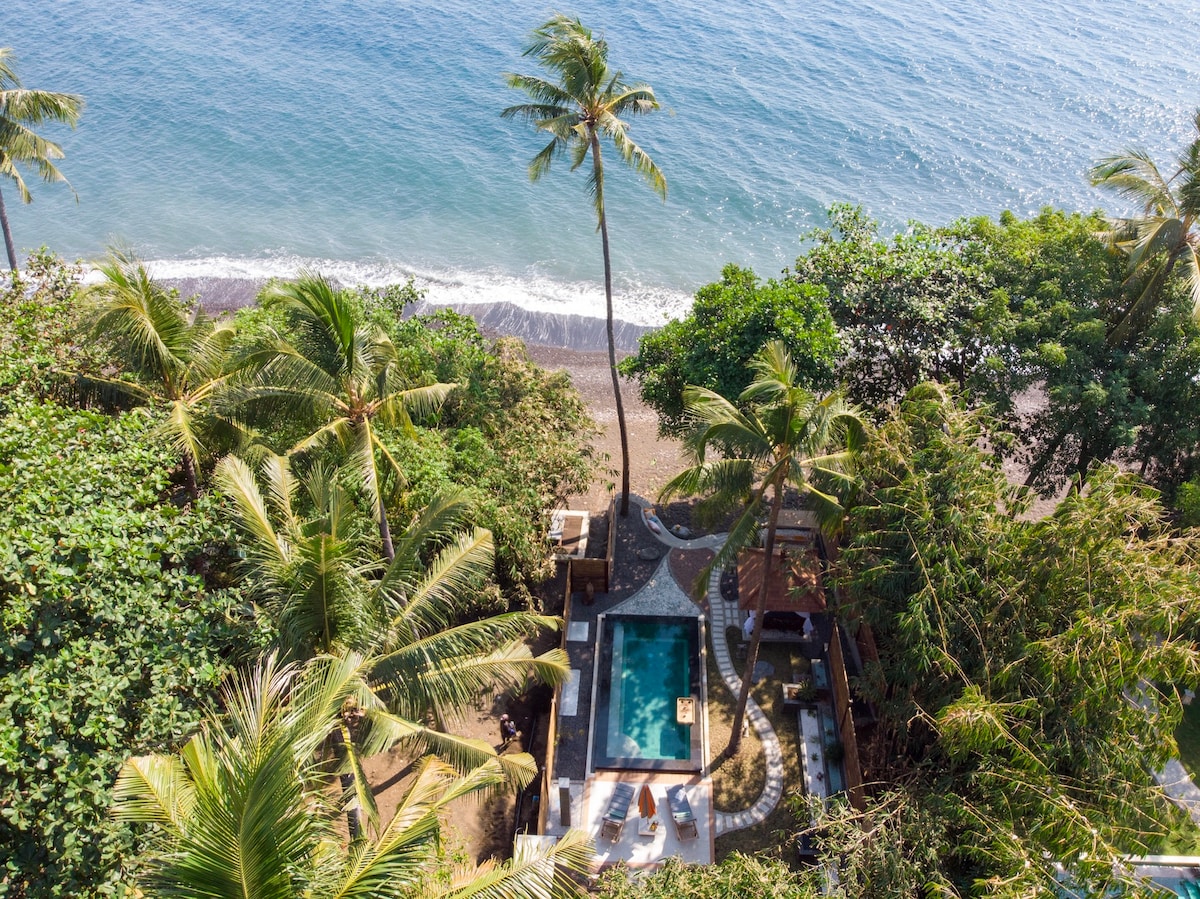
<box><xmin>0</xmin><ymin>0</ymin><xmax>1200</xmax><ymax>324</ymax></box>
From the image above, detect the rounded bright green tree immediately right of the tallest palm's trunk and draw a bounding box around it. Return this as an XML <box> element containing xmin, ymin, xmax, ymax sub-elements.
<box><xmin>622</xmin><ymin>265</ymin><xmax>839</xmax><ymax>436</ymax></box>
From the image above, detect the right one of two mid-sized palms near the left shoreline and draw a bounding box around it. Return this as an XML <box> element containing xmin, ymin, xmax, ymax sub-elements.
<box><xmin>228</xmin><ymin>272</ymin><xmax>456</xmax><ymax>562</ymax></box>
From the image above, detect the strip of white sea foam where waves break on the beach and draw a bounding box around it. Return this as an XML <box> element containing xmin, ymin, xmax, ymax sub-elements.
<box><xmin>126</xmin><ymin>256</ymin><xmax>691</xmax><ymax>326</ymax></box>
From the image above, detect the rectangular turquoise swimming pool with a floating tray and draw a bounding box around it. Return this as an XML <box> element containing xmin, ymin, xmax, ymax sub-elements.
<box><xmin>593</xmin><ymin>615</ymin><xmax>703</xmax><ymax>771</ymax></box>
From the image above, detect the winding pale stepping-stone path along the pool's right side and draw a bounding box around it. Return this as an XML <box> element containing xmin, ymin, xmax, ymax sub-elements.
<box><xmin>630</xmin><ymin>496</ymin><xmax>784</xmax><ymax>837</ymax></box>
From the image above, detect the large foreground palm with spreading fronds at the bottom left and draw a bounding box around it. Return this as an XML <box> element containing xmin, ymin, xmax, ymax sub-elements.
<box><xmin>114</xmin><ymin>655</ymin><xmax>588</xmax><ymax>899</ymax></box>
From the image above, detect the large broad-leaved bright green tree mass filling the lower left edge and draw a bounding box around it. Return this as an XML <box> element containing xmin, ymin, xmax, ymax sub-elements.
<box><xmin>0</xmin><ymin>400</ymin><xmax>243</xmax><ymax>897</ymax></box>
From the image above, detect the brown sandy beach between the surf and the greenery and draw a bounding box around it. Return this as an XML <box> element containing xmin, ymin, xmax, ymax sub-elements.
<box><xmin>170</xmin><ymin>277</ymin><xmax>684</xmax><ymax>513</ymax></box>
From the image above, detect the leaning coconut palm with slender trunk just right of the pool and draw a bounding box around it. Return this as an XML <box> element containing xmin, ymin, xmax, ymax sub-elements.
<box><xmin>662</xmin><ymin>341</ymin><xmax>864</xmax><ymax>755</ymax></box>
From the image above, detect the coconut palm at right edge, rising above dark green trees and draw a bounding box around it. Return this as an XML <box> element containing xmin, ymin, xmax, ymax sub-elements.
<box><xmin>1092</xmin><ymin>110</ymin><xmax>1200</xmax><ymax>344</ymax></box>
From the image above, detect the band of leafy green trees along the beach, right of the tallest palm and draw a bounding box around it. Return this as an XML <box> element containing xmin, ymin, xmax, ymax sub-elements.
<box><xmin>638</xmin><ymin>205</ymin><xmax>1200</xmax><ymax>499</ymax></box>
